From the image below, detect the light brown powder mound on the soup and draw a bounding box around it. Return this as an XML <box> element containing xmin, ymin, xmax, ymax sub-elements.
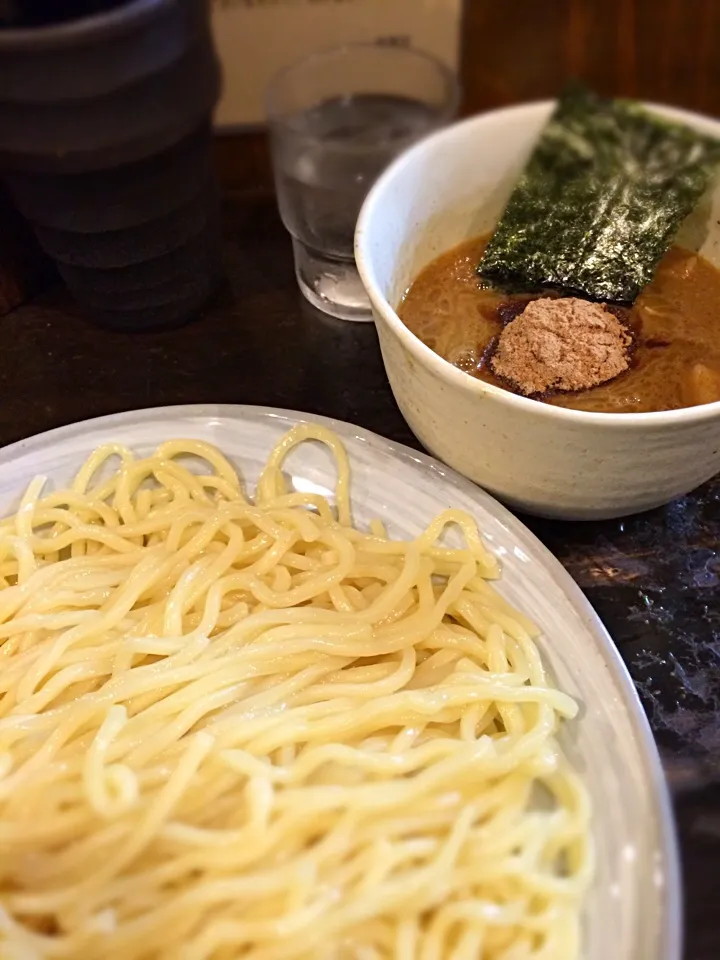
<box><xmin>490</xmin><ymin>297</ymin><xmax>633</xmax><ymax>396</ymax></box>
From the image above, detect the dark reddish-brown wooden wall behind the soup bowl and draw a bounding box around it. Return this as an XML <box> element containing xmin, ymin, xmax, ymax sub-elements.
<box><xmin>463</xmin><ymin>0</ymin><xmax>720</xmax><ymax>115</ymax></box>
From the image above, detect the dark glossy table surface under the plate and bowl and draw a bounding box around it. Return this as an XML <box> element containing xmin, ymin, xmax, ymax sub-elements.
<box><xmin>5</xmin><ymin>194</ymin><xmax>720</xmax><ymax>960</ymax></box>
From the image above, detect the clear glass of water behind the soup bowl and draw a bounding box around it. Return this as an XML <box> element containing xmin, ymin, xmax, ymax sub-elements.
<box><xmin>268</xmin><ymin>43</ymin><xmax>459</xmax><ymax>320</ymax></box>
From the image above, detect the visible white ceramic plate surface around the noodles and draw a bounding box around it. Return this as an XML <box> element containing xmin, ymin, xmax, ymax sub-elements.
<box><xmin>0</xmin><ymin>405</ymin><xmax>681</xmax><ymax>960</ymax></box>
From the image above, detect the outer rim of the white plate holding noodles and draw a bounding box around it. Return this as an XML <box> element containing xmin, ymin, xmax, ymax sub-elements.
<box><xmin>0</xmin><ymin>403</ymin><xmax>684</xmax><ymax>960</ymax></box>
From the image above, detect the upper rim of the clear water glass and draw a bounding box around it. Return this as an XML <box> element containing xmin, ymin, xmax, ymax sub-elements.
<box><xmin>264</xmin><ymin>40</ymin><xmax>462</xmax><ymax>132</ymax></box>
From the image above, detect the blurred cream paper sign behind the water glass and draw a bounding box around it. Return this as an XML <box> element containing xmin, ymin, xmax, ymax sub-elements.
<box><xmin>212</xmin><ymin>0</ymin><xmax>462</xmax><ymax>129</ymax></box>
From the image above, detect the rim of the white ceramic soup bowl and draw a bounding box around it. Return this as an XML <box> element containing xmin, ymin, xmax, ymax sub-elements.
<box><xmin>355</xmin><ymin>100</ymin><xmax>720</xmax><ymax>430</ymax></box>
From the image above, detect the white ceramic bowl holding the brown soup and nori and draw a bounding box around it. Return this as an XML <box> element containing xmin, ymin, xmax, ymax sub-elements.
<box><xmin>355</xmin><ymin>102</ymin><xmax>720</xmax><ymax>520</ymax></box>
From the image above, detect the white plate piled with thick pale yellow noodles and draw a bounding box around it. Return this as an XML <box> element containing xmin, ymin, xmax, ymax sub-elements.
<box><xmin>0</xmin><ymin>406</ymin><xmax>681</xmax><ymax>960</ymax></box>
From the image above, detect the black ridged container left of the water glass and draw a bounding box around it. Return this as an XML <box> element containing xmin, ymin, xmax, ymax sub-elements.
<box><xmin>0</xmin><ymin>0</ymin><xmax>220</xmax><ymax>330</ymax></box>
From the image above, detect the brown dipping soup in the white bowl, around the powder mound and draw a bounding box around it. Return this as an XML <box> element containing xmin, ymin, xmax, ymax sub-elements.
<box><xmin>398</xmin><ymin>234</ymin><xmax>720</xmax><ymax>413</ymax></box>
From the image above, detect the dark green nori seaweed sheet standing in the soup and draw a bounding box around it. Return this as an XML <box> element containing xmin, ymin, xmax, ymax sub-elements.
<box><xmin>478</xmin><ymin>86</ymin><xmax>720</xmax><ymax>303</ymax></box>
